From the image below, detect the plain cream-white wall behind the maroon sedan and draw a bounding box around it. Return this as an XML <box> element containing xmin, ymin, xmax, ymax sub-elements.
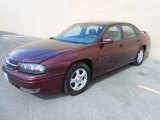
<box><xmin>0</xmin><ymin>0</ymin><xmax>160</xmax><ymax>58</ymax></box>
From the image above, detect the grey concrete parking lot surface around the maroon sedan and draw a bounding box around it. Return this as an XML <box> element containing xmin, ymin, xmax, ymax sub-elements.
<box><xmin>0</xmin><ymin>32</ymin><xmax>160</xmax><ymax>120</ymax></box>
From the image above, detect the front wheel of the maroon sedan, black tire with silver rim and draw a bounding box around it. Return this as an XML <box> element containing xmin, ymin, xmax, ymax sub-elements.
<box><xmin>63</xmin><ymin>62</ymin><xmax>91</xmax><ymax>95</ymax></box>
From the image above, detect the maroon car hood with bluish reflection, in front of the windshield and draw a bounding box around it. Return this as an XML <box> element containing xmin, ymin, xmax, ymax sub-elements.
<box><xmin>8</xmin><ymin>39</ymin><xmax>84</xmax><ymax>63</ymax></box>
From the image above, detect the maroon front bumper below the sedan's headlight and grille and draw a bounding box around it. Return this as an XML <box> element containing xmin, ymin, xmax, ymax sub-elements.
<box><xmin>2</xmin><ymin>66</ymin><xmax>64</xmax><ymax>93</ymax></box>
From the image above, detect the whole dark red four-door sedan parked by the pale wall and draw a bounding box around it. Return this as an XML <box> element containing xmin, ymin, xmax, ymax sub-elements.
<box><xmin>2</xmin><ymin>22</ymin><xmax>150</xmax><ymax>95</ymax></box>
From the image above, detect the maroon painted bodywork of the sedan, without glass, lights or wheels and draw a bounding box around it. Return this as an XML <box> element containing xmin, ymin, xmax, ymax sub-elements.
<box><xmin>2</xmin><ymin>22</ymin><xmax>150</xmax><ymax>92</ymax></box>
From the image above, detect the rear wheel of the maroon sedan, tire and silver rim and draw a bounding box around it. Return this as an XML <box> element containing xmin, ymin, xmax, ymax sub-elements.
<box><xmin>134</xmin><ymin>47</ymin><xmax>145</xmax><ymax>66</ymax></box>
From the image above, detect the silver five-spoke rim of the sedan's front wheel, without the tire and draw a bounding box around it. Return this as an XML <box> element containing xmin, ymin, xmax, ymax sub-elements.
<box><xmin>70</xmin><ymin>69</ymin><xmax>88</xmax><ymax>91</ymax></box>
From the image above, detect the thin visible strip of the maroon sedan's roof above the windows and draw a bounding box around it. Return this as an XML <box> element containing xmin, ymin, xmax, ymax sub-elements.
<box><xmin>78</xmin><ymin>21</ymin><xmax>131</xmax><ymax>26</ymax></box>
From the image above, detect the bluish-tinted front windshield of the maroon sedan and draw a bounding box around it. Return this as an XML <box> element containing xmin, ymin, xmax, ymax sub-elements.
<box><xmin>55</xmin><ymin>24</ymin><xmax>104</xmax><ymax>44</ymax></box>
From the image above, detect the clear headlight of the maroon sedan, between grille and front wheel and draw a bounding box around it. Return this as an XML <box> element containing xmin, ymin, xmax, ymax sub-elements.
<box><xmin>19</xmin><ymin>63</ymin><xmax>47</xmax><ymax>75</ymax></box>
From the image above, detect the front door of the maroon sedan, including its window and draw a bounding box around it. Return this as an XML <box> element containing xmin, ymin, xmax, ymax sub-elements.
<box><xmin>97</xmin><ymin>25</ymin><xmax>125</xmax><ymax>74</ymax></box>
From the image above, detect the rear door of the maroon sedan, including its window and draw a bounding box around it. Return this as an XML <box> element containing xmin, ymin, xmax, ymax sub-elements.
<box><xmin>121</xmin><ymin>24</ymin><xmax>140</xmax><ymax>61</ymax></box>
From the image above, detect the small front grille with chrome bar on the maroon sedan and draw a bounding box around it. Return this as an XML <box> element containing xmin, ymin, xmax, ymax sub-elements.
<box><xmin>5</xmin><ymin>58</ymin><xmax>19</xmax><ymax>70</ymax></box>
